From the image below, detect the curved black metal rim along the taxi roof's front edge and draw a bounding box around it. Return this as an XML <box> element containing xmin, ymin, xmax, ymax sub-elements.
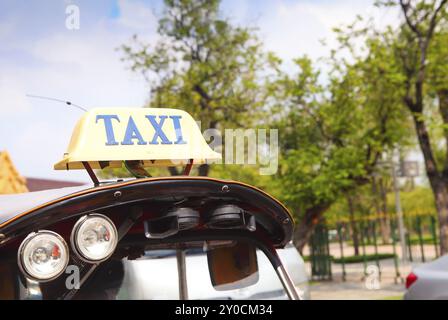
<box><xmin>0</xmin><ymin>177</ymin><xmax>293</xmax><ymax>248</ymax></box>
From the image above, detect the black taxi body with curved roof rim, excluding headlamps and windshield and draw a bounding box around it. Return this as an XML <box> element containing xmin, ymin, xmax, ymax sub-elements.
<box><xmin>0</xmin><ymin>176</ymin><xmax>298</xmax><ymax>299</ymax></box>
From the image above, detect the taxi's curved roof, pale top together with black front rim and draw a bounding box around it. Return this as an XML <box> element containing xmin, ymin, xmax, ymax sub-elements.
<box><xmin>0</xmin><ymin>176</ymin><xmax>294</xmax><ymax>247</ymax></box>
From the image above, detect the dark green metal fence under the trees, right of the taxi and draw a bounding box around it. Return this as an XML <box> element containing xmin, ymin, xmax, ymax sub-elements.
<box><xmin>303</xmin><ymin>215</ymin><xmax>439</xmax><ymax>283</ymax></box>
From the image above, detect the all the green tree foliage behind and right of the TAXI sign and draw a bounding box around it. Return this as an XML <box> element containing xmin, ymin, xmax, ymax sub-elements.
<box><xmin>116</xmin><ymin>0</ymin><xmax>448</xmax><ymax>248</ymax></box>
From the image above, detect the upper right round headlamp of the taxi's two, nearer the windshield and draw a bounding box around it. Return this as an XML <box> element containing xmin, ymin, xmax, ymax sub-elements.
<box><xmin>71</xmin><ymin>213</ymin><xmax>118</xmax><ymax>263</ymax></box>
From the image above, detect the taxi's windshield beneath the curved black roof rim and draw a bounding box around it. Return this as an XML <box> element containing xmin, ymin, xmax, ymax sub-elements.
<box><xmin>76</xmin><ymin>241</ymin><xmax>287</xmax><ymax>300</ymax></box>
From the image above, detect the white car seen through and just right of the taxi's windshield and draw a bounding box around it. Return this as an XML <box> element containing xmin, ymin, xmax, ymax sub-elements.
<box><xmin>118</xmin><ymin>244</ymin><xmax>310</xmax><ymax>300</ymax></box>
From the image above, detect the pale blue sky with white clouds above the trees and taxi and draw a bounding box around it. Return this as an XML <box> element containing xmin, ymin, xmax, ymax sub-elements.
<box><xmin>0</xmin><ymin>0</ymin><xmax>399</xmax><ymax>182</ymax></box>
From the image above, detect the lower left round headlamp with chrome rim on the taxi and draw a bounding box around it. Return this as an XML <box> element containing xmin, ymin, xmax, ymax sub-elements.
<box><xmin>17</xmin><ymin>230</ymin><xmax>69</xmax><ymax>282</ymax></box>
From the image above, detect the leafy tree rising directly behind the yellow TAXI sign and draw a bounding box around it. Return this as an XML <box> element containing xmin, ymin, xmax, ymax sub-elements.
<box><xmin>122</xmin><ymin>0</ymin><xmax>267</xmax><ymax>175</ymax></box>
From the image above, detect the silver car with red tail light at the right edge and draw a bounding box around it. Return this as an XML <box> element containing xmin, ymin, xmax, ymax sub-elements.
<box><xmin>404</xmin><ymin>255</ymin><xmax>448</xmax><ymax>300</ymax></box>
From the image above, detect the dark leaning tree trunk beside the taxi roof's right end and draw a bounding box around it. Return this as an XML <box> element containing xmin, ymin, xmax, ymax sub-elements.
<box><xmin>293</xmin><ymin>204</ymin><xmax>330</xmax><ymax>253</ymax></box>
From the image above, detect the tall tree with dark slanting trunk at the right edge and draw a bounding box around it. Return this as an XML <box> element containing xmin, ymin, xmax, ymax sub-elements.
<box><xmin>395</xmin><ymin>0</ymin><xmax>448</xmax><ymax>254</ymax></box>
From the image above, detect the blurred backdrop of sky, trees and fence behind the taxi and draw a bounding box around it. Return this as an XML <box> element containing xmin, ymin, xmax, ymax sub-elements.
<box><xmin>0</xmin><ymin>0</ymin><xmax>448</xmax><ymax>299</ymax></box>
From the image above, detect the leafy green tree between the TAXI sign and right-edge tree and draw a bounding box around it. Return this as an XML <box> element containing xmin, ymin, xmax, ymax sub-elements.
<box><xmin>274</xmin><ymin>37</ymin><xmax>407</xmax><ymax>249</ymax></box>
